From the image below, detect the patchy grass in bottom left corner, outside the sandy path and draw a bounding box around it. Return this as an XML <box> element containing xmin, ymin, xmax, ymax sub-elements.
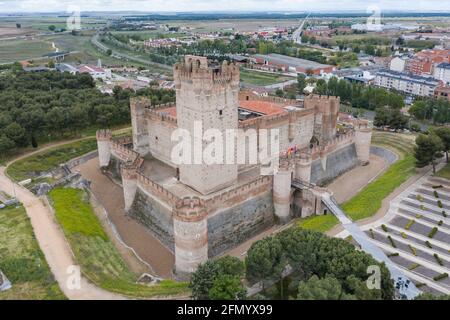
<box><xmin>0</xmin><ymin>207</ymin><xmax>65</xmax><ymax>300</ymax></box>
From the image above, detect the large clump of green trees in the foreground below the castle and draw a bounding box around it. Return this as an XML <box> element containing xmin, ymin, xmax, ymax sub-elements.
<box><xmin>190</xmin><ymin>228</ymin><xmax>394</xmax><ymax>300</ymax></box>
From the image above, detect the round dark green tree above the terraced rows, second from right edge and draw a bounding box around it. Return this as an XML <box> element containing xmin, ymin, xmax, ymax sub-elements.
<box><xmin>414</xmin><ymin>133</ymin><xmax>444</xmax><ymax>173</ymax></box>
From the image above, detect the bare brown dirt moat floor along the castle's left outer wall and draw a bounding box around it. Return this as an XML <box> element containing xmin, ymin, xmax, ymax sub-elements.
<box><xmin>74</xmin><ymin>158</ymin><xmax>175</xmax><ymax>278</ymax></box>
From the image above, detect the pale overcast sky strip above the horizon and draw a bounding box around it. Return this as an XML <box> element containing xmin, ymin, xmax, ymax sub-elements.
<box><xmin>0</xmin><ymin>0</ymin><xmax>450</xmax><ymax>13</ymax></box>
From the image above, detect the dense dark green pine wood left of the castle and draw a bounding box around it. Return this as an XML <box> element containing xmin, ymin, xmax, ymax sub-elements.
<box><xmin>0</xmin><ymin>71</ymin><xmax>175</xmax><ymax>154</ymax></box>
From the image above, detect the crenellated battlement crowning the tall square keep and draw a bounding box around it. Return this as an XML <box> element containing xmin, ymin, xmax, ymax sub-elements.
<box><xmin>173</xmin><ymin>55</ymin><xmax>240</xmax><ymax>89</ymax></box>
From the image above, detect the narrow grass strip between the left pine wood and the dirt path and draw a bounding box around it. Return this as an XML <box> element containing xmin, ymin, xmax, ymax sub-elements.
<box><xmin>7</xmin><ymin>138</ymin><xmax>97</xmax><ymax>181</ymax></box>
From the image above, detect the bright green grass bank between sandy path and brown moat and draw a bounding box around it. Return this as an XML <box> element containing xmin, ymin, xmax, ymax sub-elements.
<box><xmin>50</xmin><ymin>188</ymin><xmax>189</xmax><ymax>297</ymax></box>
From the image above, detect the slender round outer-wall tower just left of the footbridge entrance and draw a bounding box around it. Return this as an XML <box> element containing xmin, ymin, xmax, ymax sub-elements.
<box><xmin>273</xmin><ymin>161</ymin><xmax>292</xmax><ymax>223</ymax></box>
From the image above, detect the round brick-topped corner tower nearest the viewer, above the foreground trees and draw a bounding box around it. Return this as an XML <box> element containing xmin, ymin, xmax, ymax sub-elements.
<box><xmin>173</xmin><ymin>197</ymin><xmax>208</xmax><ymax>278</ymax></box>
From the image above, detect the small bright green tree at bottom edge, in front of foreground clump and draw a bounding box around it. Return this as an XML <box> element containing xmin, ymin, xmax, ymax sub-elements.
<box><xmin>209</xmin><ymin>274</ymin><xmax>247</xmax><ymax>300</ymax></box>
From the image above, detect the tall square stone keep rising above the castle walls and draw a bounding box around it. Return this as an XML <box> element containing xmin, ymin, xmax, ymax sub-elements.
<box><xmin>174</xmin><ymin>56</ymin><xmax>239</xmax><ymax>194</ymax></box>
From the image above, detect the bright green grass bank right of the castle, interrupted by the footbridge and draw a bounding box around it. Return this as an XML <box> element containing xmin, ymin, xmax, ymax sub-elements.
<box><xmin>299</xmin><ymin>131</ymin><xmax>415</xmax><ymax>232</ymax></box>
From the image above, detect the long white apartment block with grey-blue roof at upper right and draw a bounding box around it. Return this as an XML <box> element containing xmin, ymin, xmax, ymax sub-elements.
<box><xmin>374</xmin><ymin>70</ymin><xmax>440</xmax><ymax>97</ymax></box>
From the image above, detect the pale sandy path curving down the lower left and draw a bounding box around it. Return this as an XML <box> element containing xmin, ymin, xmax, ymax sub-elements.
<box><xmin>0</xmin><ymin>167</ymin><xmax>125</xmax><ymax>300</ymax></box>
